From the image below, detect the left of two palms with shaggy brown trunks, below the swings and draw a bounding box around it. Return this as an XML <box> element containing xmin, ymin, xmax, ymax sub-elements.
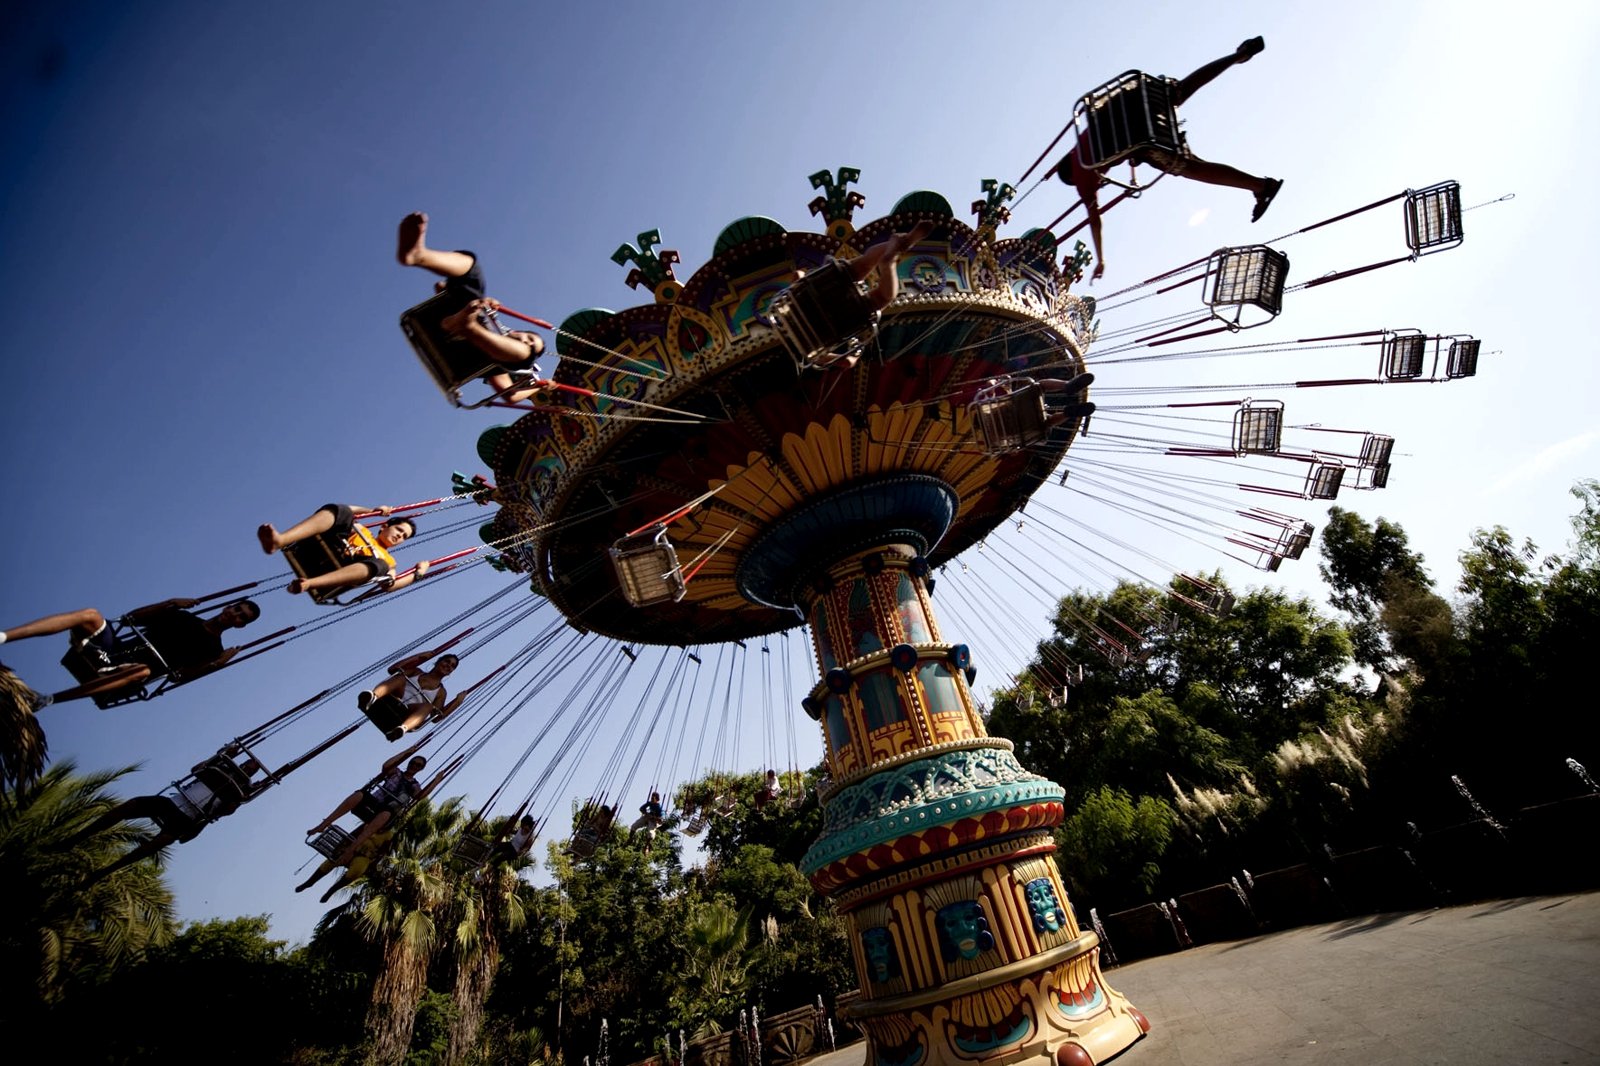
<box><xmin>318</xmin><ymin>799</ymin><xmax>464</xmax><ymax>1066</ymax></box>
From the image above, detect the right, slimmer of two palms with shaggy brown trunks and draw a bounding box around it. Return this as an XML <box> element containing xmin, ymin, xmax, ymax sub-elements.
<box><xmin>445</xmin><ymin>825</ymin><xmax>533</xmax><ymax>1064</ymax></box>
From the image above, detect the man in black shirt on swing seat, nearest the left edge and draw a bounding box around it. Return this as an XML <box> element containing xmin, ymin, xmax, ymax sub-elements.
<box><xmin>0</xmin><ymin>599</ymin><xmax>261</xmax><ymax>699</ymax></box>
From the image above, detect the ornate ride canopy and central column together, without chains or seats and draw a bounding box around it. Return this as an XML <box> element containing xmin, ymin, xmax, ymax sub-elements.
<box><xmin>478</xmin><ymin>170</ymin><xmax>1149</xmax><ymax>1066</ymax></box>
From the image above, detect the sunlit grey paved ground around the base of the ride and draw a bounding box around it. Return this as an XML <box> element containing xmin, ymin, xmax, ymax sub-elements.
<box><xmin>808</xmin><ymin>893</ymin><xmax>1600</xmax><ymax>1066</ymax></box>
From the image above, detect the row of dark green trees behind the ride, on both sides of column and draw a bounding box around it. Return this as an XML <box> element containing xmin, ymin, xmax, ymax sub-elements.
<box><xmin>0</xmin><ymin>482</ymin><xmax>1600</xmax><ymax>1064</ymax></box>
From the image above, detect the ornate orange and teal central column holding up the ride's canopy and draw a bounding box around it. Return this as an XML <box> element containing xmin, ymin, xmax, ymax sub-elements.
<box><xmin>764</xmin><ymin>505</ymin><xmax>1149</xmax><ymax>1066</ymax></box>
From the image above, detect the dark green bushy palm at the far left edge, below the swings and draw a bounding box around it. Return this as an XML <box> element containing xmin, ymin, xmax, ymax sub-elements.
<box><xmin>0</xmin><ymin>762</ymin><xmax>174</xmax><ymax>1018</ymax></box>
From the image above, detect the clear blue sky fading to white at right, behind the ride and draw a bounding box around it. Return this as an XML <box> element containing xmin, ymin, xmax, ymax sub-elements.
<box><xmin>0</xmin><ymin>0</ymin><xmax>1600</xmax><ymax>938</ymax></box>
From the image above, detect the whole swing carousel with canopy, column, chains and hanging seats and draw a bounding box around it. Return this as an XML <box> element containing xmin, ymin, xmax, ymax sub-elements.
<box><xmin>9</xmin><ymin>58</ymin><xmax>1478</xmax><ymax>1066</ymax></box>
